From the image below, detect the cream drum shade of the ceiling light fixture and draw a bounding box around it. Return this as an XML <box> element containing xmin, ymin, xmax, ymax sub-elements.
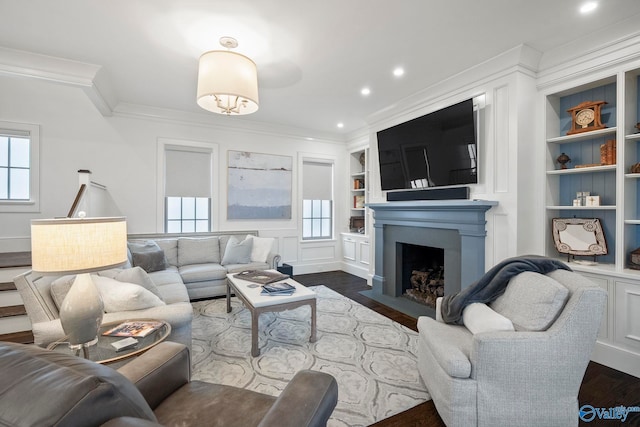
<box><xmin>197</xmin><ymin>50</ymin><xmax>258</xmax><ymax>115</ymax></box>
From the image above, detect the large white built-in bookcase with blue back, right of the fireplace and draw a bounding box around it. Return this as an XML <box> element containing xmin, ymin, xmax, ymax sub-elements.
<box><xmin>543</xmin><ymin>64</ymin><xmax>640</xmax><ymax>376</ymax></box>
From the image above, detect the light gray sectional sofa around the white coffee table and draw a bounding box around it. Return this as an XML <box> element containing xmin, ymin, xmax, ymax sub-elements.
<box><xmin>14</xmin><ymin>231</ymin><xmax>280</xmax><ymax>347</ymax></box>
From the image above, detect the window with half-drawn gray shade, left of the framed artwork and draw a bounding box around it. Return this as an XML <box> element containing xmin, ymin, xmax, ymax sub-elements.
<box><xmin>164</xmin><ymin>145</ymin><xmax>212</xmax><ymax>233</ymax></box>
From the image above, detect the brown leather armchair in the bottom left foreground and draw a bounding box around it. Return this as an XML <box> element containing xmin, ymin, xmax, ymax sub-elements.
<box><xmin>0</xmin><ymin>341</ymin><xmax>338</xmax><ymax>427</ymax></box>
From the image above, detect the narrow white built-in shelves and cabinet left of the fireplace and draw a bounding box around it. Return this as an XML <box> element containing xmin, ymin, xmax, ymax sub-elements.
<box><xmin>341</xmin><ymin>148</ymin><xmax>371</xmax><ymax>278</ymax></box>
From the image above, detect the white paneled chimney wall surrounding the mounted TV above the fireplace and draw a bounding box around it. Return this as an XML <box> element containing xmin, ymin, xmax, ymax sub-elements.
<box><xmin>352</xmin><ymin>46</ymin><xmax>542</xmax><ymax>269</ymax></box>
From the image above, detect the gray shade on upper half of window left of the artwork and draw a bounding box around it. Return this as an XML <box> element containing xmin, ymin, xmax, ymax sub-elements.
<box><xmin>165</xmin><ymin>147</ymin><xmax>211</xmax><ymax>197</ymax></box>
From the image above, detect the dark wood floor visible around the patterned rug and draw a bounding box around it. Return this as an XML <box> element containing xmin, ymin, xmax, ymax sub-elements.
<box><xmin>295</xmin><ymin>271</ymin><xmax>640</xmax><ymax>427</ymax></box>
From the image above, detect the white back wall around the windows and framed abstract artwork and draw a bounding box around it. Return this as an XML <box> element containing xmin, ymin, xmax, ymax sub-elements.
<box><xmin>0</xmin><ymin>76</ymin><xmax>348</xmax><ymax>273</ymax></box>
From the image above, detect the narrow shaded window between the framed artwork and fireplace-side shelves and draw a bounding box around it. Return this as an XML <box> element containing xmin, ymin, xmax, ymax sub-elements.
<box><xmin>302</xmin><ymin>160</ymin><xmax>333</xmax><ymax>240</ymax></box>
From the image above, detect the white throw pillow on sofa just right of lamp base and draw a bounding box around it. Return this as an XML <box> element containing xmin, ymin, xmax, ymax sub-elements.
<box><xmin>91</xmin><ymin>275</ymin><xmax>165</xmax><ymax>313</ymax></box>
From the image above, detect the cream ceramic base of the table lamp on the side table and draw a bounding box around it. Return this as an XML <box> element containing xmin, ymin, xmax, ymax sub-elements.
<box><xmin>60</xmin><ymin>273</ymin><xmax>104</xmax><ymax>349</ymax></box>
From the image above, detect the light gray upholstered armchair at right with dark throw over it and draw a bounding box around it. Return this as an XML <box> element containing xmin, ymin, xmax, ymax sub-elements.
<box><xmin>418</xmin><ymin>270</ymin><xmax>606</xmax><ymax>427</ymax></box>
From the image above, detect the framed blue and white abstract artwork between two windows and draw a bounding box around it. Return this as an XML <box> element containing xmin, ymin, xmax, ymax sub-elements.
<box><xmin>227</xmin><ymin>150</ymin><xmax>293</xmax><ymax>219</ymax></box>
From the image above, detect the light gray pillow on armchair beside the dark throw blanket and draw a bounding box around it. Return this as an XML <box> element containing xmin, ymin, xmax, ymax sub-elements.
<box><xmin>490</xmin><ymin>271</ymin><xmax>569</xmax><ymax>331</ymax></box>
